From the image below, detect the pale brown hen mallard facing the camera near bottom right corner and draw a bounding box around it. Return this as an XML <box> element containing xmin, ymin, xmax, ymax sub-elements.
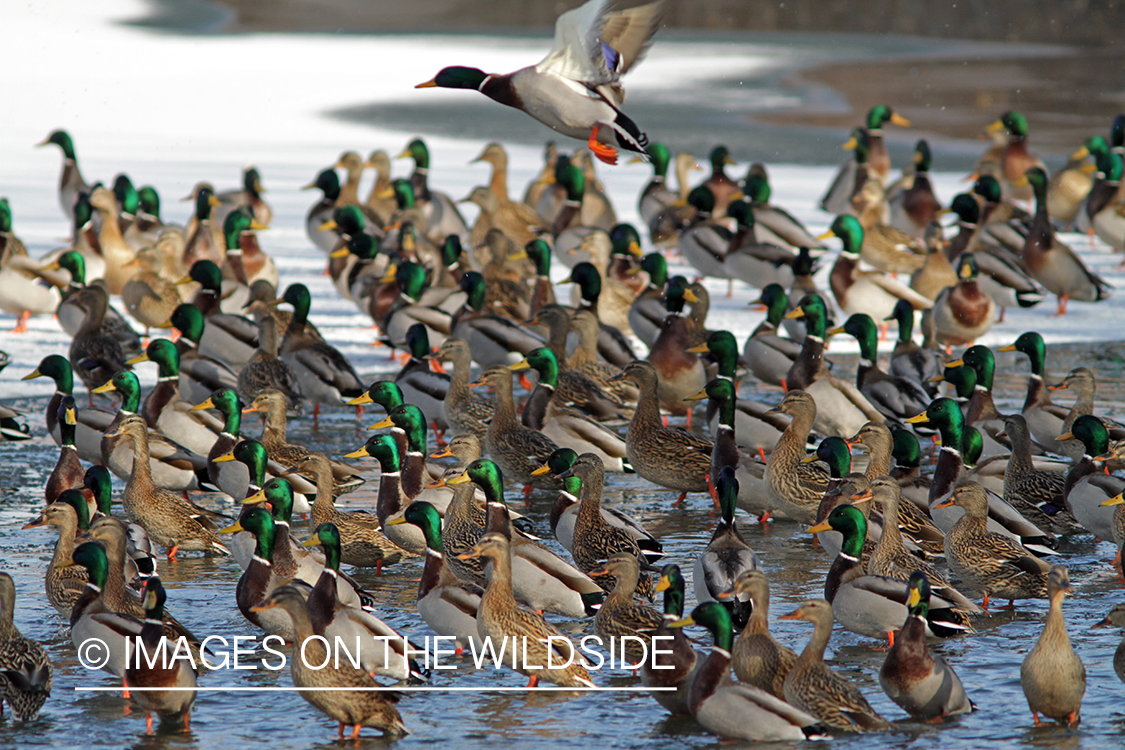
<box><xmin>1019</xmin><ymin>566</ymin><xmax>1086</xmax><ymax>726</ymax></box>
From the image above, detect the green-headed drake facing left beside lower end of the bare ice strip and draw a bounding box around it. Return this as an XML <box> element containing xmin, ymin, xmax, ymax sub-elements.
<box><xmin>278</xmin><ymin>283</ymin><xmax>363</xmax><ymax>414</ymax></box>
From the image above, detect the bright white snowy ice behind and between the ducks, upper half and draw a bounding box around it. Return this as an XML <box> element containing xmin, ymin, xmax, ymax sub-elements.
<box><xmin>0</xmin><ymin>0</ymin><xmax>1125</xmax><ymax>398</ymax></box>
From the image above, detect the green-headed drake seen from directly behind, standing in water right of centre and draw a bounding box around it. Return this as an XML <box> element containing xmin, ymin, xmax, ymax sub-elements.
<box><xmin>692</xmin><ymin>467</ymin><xmax>758</xmax><ymax>629</ymax></box>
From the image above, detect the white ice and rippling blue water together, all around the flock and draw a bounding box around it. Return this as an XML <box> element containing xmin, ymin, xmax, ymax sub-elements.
<box><xmin>0</xmin><ymin>0</ymin><xmax>1125</xmax><ymax>750</ymax></box>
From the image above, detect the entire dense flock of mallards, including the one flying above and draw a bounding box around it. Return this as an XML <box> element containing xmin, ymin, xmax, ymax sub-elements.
<box><xmin>0</xmin><ymin>0</ymin><xmax>1125</xmax><ymax>740</ymax></box>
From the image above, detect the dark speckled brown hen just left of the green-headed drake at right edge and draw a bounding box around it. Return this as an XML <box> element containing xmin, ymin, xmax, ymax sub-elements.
<box><xmin>1004</xmin><ymin>414</ymin><xmax>1078</xmax><ymax>534</ymax></box>
